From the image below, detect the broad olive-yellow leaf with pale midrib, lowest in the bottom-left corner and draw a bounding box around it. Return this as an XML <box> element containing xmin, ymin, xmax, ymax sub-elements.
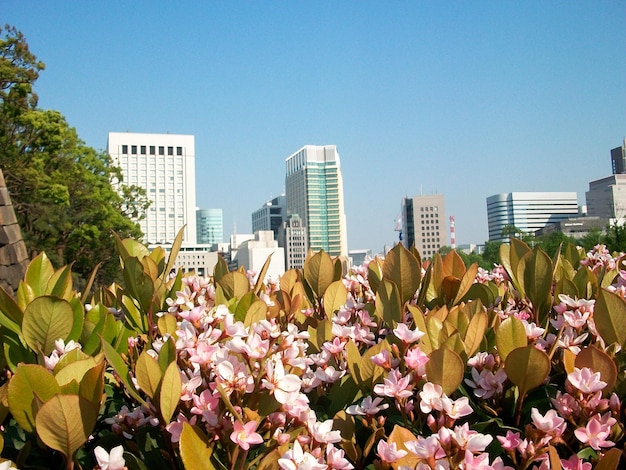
<box><xmin>36</xmin><ymin>395</ymin><xmax>98</xmax><ymax>461</ymax></box>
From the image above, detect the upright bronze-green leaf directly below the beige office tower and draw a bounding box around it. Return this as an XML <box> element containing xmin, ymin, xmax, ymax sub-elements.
<box><xmin>383</xmin><ymin>243</ymin><xmax>422</xmax><ymax>304</ymax></box>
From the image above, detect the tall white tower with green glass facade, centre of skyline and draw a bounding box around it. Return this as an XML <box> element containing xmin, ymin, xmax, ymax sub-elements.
<box><xmin>285</xmin><ymin>145</ymin><xmax>348</xmax><ymax>256</ymax></box>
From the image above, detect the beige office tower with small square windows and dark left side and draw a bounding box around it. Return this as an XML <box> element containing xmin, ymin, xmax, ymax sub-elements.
<box><xmin>402</xmin><ymin>194</ymin><xmax>448</xmax><ymax>258</ymax></box>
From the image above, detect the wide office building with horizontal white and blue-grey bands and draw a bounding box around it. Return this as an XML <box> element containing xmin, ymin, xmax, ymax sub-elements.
<box><xmin>487</xmin><ymin>192</ymin><xmax>578</xmax><ymax>242</ymax></box>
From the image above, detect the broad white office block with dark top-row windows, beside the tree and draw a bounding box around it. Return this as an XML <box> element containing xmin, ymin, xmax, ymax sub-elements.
<box><xmin>107</xmin><ymin>132</ymin><xmax>196</xmax><ymax>245</ymax></box>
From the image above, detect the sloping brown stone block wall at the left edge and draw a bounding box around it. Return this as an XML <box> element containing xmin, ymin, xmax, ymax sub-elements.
<box><xmin>0</xmin><ymin>170</ymin><xmax>29</xmax><ymax>295</ymax></box>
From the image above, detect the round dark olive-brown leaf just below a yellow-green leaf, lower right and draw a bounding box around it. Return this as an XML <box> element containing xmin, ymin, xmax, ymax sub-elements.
<box><xmin>504</xmin><ymin>346</ymin><xmax>550</xmax><ymax>397</ymax></box>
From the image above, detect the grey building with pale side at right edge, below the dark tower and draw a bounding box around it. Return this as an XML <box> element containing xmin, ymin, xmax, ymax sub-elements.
<box><xmin>585</xmin><ymin>173</ymin><xmax>626</xmax><ymax>219</ymax></box>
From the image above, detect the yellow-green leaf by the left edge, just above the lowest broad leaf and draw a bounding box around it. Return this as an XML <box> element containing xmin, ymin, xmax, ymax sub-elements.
<box><xmin>8</xmin><ymin>364</ymin><xmax>61</xmax><ymax>432</ymax></box>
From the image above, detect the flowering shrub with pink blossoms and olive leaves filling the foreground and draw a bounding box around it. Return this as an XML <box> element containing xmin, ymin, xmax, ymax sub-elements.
<box><xmin>0</xmin><ymin>235</ymin><xmax>626</xmax><ymax>470</ymax></box>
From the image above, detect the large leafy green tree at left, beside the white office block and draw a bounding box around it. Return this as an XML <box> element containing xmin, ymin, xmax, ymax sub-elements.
<box><xmin>0</xmin><ymin>26</ymin><xmax>149</xmax><ymax>283</ymax></box>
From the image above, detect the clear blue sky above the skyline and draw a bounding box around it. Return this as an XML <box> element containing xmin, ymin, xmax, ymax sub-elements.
<box><xmin>0</xmin><ymin>0</ymin><xmax>626</xmax><ymax>252</ymax></box>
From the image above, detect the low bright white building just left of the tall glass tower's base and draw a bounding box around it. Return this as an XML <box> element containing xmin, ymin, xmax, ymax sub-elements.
<box><xmin>236</xmin><ymin>230</ymin><xmax>285</xmax><ymax>280</ymax></box>
